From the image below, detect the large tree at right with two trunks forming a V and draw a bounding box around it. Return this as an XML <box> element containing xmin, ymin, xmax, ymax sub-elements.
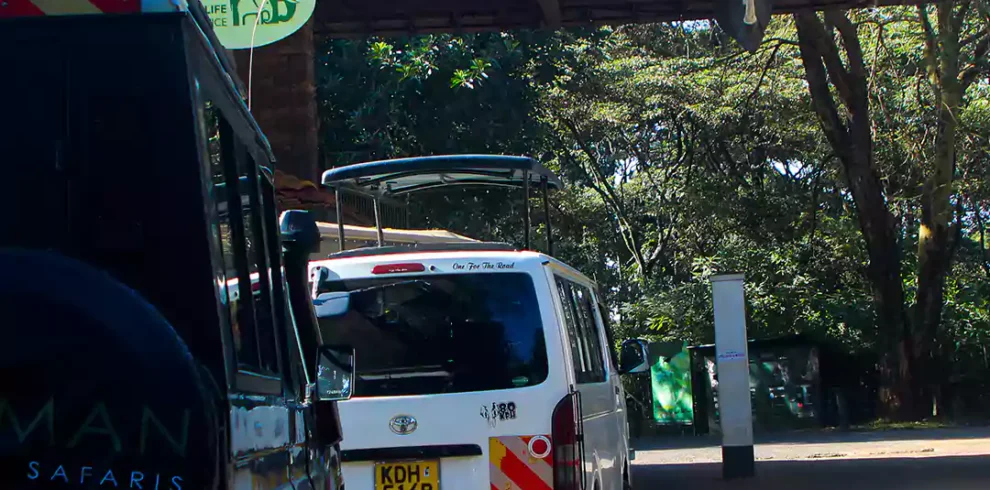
<box><xmin>795</xmin><ymin>2</ymin><xmax>988</xmax><ymax>418</ymax></box>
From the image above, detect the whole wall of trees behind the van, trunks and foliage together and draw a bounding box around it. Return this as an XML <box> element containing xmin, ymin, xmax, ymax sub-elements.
<box><xmin>317</xmin><ymin>5</ymin><xmax>990</xmax><ymax>417</ymax></box>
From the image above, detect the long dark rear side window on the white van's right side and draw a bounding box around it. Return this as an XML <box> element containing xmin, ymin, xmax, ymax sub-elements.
<box><xmin>556</xmin><ymin>277</ymin><xmax>605</xmax><ymax>384</ymax></box>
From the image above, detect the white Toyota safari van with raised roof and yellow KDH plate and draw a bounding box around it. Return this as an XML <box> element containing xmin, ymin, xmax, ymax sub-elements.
<box><xmin>310</xmin><ymin>156</ymin><xmax>648</xmax><ymax>490</ymax></box>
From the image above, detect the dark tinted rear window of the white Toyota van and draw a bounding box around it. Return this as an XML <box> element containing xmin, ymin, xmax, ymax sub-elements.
<box><xmin>320</xmin><ymin>272</ymin><xmax>547</xmax><ymax>397</ymax></box>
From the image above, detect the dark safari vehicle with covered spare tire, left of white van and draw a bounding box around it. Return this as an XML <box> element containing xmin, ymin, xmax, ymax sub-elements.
<box><xmin>0</xmin><ymin>0</ymin><xmax>353</xmax><ymax>490</ymax></box>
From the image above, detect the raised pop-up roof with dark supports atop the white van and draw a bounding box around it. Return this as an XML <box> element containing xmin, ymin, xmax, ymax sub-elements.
<box><xmin>323</xmin><ymin>155</ymin><xmax>564</xmax><ymax>257</ymax></box>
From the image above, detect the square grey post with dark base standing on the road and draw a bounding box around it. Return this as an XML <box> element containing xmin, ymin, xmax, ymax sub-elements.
<box><xmin>712</xmin><ymin>274</ymin><xmax>754</xmax><ymax>479</ymax></box>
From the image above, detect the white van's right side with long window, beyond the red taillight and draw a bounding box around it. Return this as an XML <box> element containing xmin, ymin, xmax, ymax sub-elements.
<box><xmin>555</xmin><ymin>276</ymin><xmax>621</xmax><ymax>490</ymax></box>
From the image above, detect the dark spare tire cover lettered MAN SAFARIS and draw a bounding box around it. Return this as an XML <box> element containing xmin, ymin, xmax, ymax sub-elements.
<box><xmin>0</xmin><ymin>249</ymin><xmax>220</xmax><ymax>490</ymax></box>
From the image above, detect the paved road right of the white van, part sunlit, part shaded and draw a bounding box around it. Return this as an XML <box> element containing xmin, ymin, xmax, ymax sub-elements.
<box><xmin>633</xmin><ymin>428</ymin><xmax>990</xmax><ymax>490</ymax></box>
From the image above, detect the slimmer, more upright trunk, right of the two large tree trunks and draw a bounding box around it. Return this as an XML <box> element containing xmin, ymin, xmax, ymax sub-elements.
<box><xmin>912</xmin><ymin>1</ymin><xmax>964</xmax><ymax>416</ymax></box>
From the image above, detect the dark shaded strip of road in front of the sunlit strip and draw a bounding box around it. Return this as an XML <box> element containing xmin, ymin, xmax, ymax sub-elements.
<box><xmin>633</xmin><ymin>456</ymin><xmax>990</xmax><ymax>490</ymax></box>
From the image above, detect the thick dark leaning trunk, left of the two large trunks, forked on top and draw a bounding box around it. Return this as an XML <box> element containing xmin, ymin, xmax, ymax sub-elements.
<box><xmin>794</xmin><ymin>11</ymin><xmax>917</xmax><ymax>419</ymax></box>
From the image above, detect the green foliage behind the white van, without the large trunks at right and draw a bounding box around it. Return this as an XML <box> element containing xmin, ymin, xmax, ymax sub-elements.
<box><xmin>317</xmin><ymin>11</ymin><xmax>990</xmax><ymax>410</ymax></box>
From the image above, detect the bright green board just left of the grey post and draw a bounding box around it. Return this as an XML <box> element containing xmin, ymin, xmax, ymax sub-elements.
<box><xmin>650</xmin><ymin>342</ymin><xmax>694</xmax><ymax>425</ymax></box>
